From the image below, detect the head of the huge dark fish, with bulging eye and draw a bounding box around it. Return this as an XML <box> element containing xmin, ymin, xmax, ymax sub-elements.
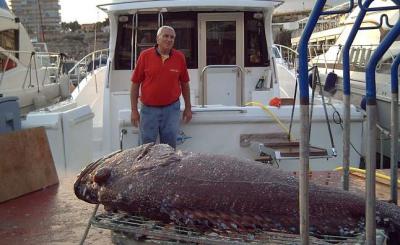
<box><xmin>74</xmin><ymin>143</ymin><xmax>180</xmax><ymax>204</ymax></box>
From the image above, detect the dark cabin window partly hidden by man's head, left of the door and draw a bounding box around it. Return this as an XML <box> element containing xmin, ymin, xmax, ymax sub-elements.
<box><xmin>163</xmin><ymin>12</ymin><xmax>198</xmax><ymax>69</ymax></box>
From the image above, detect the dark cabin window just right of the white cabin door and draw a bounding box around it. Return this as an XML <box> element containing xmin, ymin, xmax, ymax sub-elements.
<box><xmin>244</xmin><ymin>12</ymin><xmax>270</xmax><ymax>67</ymax></box>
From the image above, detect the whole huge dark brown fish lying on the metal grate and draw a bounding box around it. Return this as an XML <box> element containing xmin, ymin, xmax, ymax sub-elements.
<box><xmin>74</xmin><ymin>144</ymin><xmax>400</xmax><ymax>242</ymax></box>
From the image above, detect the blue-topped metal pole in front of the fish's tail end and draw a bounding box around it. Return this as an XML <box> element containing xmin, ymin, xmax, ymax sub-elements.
<box><xmin>365</xmin><ymin>17</ymin><xmax>400</xmax><ymax>245</ymax></box>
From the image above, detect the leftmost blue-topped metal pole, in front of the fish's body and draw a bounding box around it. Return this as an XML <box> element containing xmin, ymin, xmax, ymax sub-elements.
<box><xmin>298</xmin><ymin>0</ymin><xmax>326</xmax><ymax>245</ymax></box>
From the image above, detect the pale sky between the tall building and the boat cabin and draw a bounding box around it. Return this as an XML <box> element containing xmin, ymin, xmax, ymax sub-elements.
<box><xmin>7</xmin><ymin>0</ymin><xmax>110</xmax><ymax>24</ymax></box>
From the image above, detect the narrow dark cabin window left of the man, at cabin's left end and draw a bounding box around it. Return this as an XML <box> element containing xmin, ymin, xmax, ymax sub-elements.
<box><xmin>115</xmin><ymin>15</ymin><xmax>133</xmax><ymax>70</ymax></box>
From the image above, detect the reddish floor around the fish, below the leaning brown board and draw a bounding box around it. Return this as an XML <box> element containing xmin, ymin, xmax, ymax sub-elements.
<box><xmin>0</xmin><ymin>171</ymin><xmax>400</xmax><ymax>245</ymax></box>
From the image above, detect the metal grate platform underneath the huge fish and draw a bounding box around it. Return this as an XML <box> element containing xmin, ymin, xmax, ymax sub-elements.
<box><xmin>90</xmin><ymin>213</ymin><xmax>376</xmax><ymax>245</ymax></box>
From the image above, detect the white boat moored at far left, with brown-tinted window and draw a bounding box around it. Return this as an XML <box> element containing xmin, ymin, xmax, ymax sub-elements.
<box><xmin>0</xmin><ymin>3</ymin><xmax>69</xmax><ymax>114</ymax></box>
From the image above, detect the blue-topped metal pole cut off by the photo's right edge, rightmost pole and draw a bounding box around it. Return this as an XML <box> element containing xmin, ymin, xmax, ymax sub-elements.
<box><xmin>390</xmin><ymin>53</ymin><xmax>400</xmax><ymax>204</ymax></box>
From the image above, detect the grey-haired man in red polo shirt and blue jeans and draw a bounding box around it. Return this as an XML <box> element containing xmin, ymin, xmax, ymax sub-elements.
<box><xmin>131</xmin><ymin>26</ymin><xmax>192</xmax><ymax>148</ymax></box>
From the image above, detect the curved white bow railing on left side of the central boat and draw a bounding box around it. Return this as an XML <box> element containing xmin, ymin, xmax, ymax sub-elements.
<box><xmin>68</xmin><ymin>49</ymin><xmax>109</xmax><ymax>86</ymax></box>
